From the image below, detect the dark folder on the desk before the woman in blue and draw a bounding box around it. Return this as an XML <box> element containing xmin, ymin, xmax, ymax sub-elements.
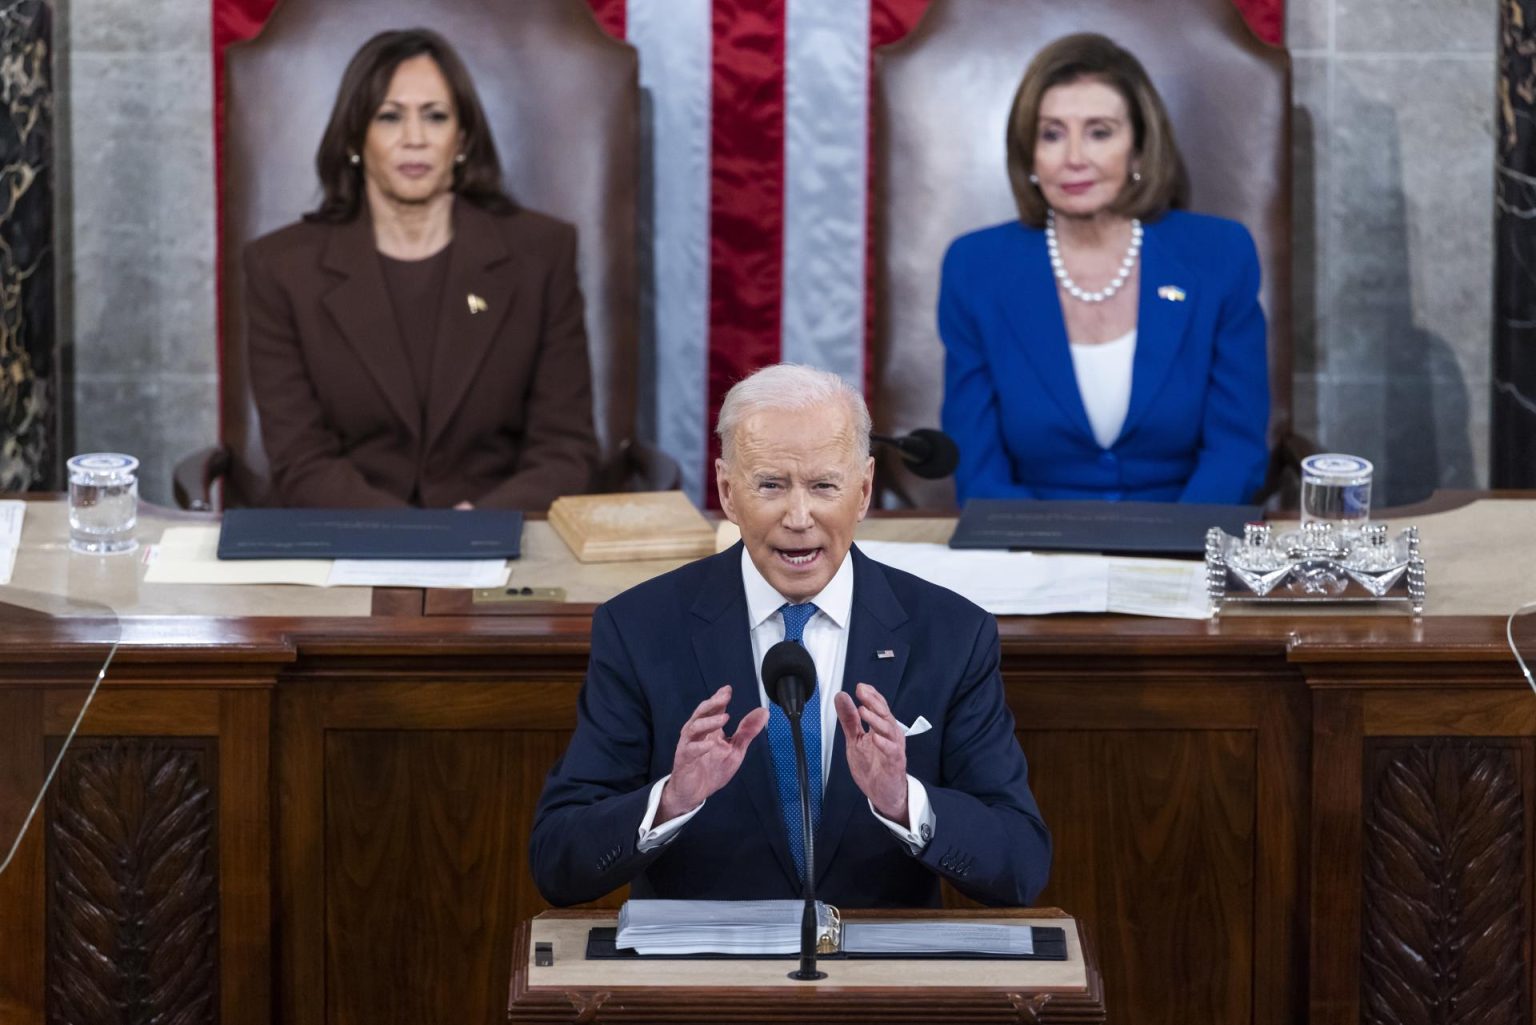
<box><xmin>949</xmin><ymin>498</ymin><xmax>1263</xmax><ymax>555</ymax></box>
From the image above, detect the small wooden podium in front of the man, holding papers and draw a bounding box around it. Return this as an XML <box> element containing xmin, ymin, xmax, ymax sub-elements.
<box><xmin>507</xmin><ymin>908</ymin><xmax>1106</xmax><ymax>1025</ymax></box>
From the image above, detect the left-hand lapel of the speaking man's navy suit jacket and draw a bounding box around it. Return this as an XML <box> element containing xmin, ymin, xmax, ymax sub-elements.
<box><xmin>691</xmin><ymin>542</ymin><xmax>804</xmax><ymax>888</ymax></box>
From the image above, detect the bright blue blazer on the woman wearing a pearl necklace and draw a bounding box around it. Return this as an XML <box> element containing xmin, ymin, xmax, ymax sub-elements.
<box><xmin>938</xmin><ymin>211</ymin><xmax>1269</xmax><ymax>503</ymax></box>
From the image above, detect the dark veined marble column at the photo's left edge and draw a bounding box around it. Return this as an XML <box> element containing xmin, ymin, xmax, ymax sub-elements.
<box><xmin>0</xmin><ymin>0</ymin><xmax>61</xmax><ymax>492</ymax></box>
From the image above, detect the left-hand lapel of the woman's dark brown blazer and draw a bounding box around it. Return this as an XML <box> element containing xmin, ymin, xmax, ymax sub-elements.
<box><xmin>321</xmin><ymin>204</ymin><xmax>421</xmax><ymax>435</ymax></box>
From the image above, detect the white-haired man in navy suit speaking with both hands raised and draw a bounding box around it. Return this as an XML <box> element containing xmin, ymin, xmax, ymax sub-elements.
<box><xmin>531</xmin><ymin>366</ymin><xmax>1051</xmax><ymax>907</ymax></box>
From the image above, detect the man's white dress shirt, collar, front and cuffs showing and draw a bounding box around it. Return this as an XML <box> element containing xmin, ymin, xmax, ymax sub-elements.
<box><xmin>637</xmin><ymin>547</ymin><xmax>935</xmax><ymax>854</ymax></box>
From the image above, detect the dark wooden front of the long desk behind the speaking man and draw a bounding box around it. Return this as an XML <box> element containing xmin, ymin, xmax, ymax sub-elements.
<box><xmin>0</xmin><ymin>491</ymin><xmax>1536</xmax><ymax>1025</ymax></box>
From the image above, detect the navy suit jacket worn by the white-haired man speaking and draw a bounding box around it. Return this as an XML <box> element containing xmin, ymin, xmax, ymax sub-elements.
<box><xmin>530</xmin><ymin>544</ymin><xmax>1051</xmax><ymax>907</ymax></box>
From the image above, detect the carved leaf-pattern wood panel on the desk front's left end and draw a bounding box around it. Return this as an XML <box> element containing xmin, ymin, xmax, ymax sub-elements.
<box><xmin>45</xmin><ymin>738</ymin><xmax>220</xmax><ymax>1025</ymax></box>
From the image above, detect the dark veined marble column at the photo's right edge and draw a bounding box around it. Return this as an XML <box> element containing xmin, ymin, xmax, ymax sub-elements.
<box><xmin>1490</xmin><ymin>0</ymin><xmax>1536</xmax><ymax>487</ymax></box>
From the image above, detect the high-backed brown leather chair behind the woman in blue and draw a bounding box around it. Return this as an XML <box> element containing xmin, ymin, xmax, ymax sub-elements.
<box><xmin>871</xmin><ymin>0</ymin><xmax>1295</xmax><ymax>509</ymax></box>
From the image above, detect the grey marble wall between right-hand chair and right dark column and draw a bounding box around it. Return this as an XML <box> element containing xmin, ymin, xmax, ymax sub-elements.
<box><xmin>1287</xmin><ymin>0</ymin><xmax>1498</xmax><ymax>504</ymax></box>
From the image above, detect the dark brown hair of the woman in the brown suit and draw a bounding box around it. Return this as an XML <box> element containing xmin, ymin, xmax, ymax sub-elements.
<box><xmin>304</xmin><ymin>29</ymin><xmax>518</xmax><ymax>224</ymax></box>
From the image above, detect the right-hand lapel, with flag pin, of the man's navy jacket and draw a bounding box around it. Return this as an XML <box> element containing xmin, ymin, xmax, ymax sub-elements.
<box><xmin>816</xmin><ymin>547</ymin><xmax>911</xmax><ymax>885</ymax></box>
